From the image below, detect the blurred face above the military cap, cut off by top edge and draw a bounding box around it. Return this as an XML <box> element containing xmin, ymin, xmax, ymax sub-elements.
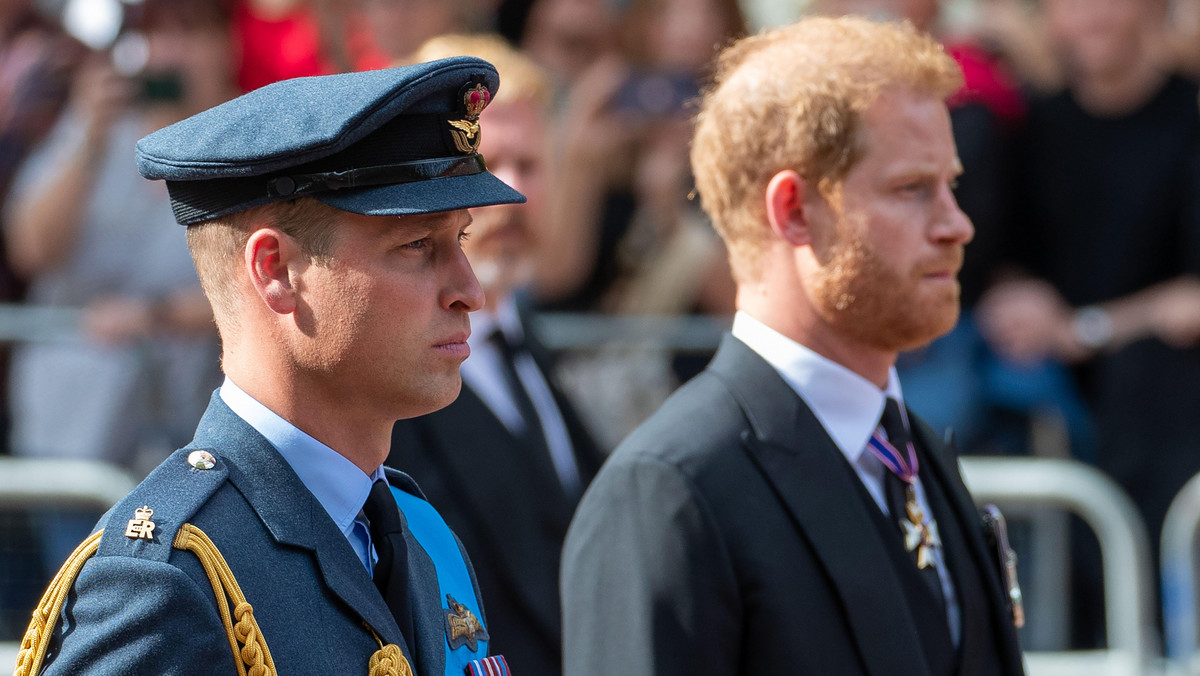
<box><xmin>361</xmin><ymin>0</ymin><xmax>466</xmax><ymax>59</ymax></box>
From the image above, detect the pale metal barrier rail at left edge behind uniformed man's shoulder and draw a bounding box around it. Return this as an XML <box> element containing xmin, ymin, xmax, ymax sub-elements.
<box><xmin>0</xmin><ymin>457</ymin><xmax>137</xmax><ymax>671</ymax></box>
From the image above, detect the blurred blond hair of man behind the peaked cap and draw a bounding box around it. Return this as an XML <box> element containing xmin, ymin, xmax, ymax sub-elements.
<box><xmin>413</xmin><ymin>34</ymin><xmax>553</xmax><ymax>108</ymax></box>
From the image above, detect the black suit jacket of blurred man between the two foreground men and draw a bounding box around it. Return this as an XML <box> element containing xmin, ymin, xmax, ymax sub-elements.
<box><xmin>388</xmin><ymin>327</ymin><xmax>604</xmax><ymax>676</ymax></box>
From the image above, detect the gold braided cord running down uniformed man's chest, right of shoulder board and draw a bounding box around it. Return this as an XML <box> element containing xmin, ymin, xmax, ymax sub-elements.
<box><xmin>174</xmin><ymin>524</ymin><xmax>276</xmax><ymax>676</ymax></box>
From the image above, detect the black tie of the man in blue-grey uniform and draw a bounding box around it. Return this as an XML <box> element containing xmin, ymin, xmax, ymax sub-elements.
<box><xmin>362</xmin><ymin>479</ymin><xmax>416</xmax><ymax>654</ymax></box>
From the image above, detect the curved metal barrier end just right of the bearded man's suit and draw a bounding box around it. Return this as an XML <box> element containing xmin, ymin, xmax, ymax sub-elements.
<box><xmin>961</xmin><ymin>457</ymin><xmax>1162</xmax><ymax>676</ymax></box>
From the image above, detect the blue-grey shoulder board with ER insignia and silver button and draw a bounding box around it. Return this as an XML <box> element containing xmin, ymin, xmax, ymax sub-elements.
<box><xmin>96</xmin><ymin>448</ymin><xmax>229</xmax><ymax>562</ymax></box>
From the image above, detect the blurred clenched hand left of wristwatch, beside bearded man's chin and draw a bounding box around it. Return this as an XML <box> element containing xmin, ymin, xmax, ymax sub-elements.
<box><xmin>976</xmin><ymin>280</ymin><xmax>1086</xmax><ymax>363</ymax></box>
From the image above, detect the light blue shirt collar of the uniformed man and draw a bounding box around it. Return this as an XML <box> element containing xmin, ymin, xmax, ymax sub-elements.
<box><xmin>220</xmin><ymin>376</ymin><xmax>386</xmax><ymax>533</ymax></box>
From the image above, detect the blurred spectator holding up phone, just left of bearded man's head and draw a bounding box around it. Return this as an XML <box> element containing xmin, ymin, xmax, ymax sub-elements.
<box><xmin>527</xmin><ymin>0</ymin><xmax>745</xmax><ymax>447</ymax></box>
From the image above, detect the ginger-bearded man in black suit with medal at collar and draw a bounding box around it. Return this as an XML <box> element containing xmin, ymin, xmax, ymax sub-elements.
<box><xmin>562</xmin><ymin>18</ymin><xmax>1022</xmax><ymax>676</ymax></box>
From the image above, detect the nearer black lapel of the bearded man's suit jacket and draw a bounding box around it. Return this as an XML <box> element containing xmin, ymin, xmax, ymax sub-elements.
<box><xmin>709</xmin><ymin>336</ymin><xmax>929</xmax><ymax>676</ymax></box>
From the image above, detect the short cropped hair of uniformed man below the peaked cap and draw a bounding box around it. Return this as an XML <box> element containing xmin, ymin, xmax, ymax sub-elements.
<box><xmin>187</xmin><ymin>197</ymin><xmax>338</xmax><ymax>339</ymax></box>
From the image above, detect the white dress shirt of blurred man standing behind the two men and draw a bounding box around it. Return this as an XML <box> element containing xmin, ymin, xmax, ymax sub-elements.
<box><xmin>461</xmin><ymin>299</ymin><xmax>581</xmax><ymax>495</ymax></box>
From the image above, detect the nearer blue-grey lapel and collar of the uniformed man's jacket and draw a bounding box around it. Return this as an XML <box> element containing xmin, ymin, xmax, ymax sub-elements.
<box><xmin>193</xmin><ymin>394</ymin><xmax>404</xmax><ymax>646</ymax></box>
